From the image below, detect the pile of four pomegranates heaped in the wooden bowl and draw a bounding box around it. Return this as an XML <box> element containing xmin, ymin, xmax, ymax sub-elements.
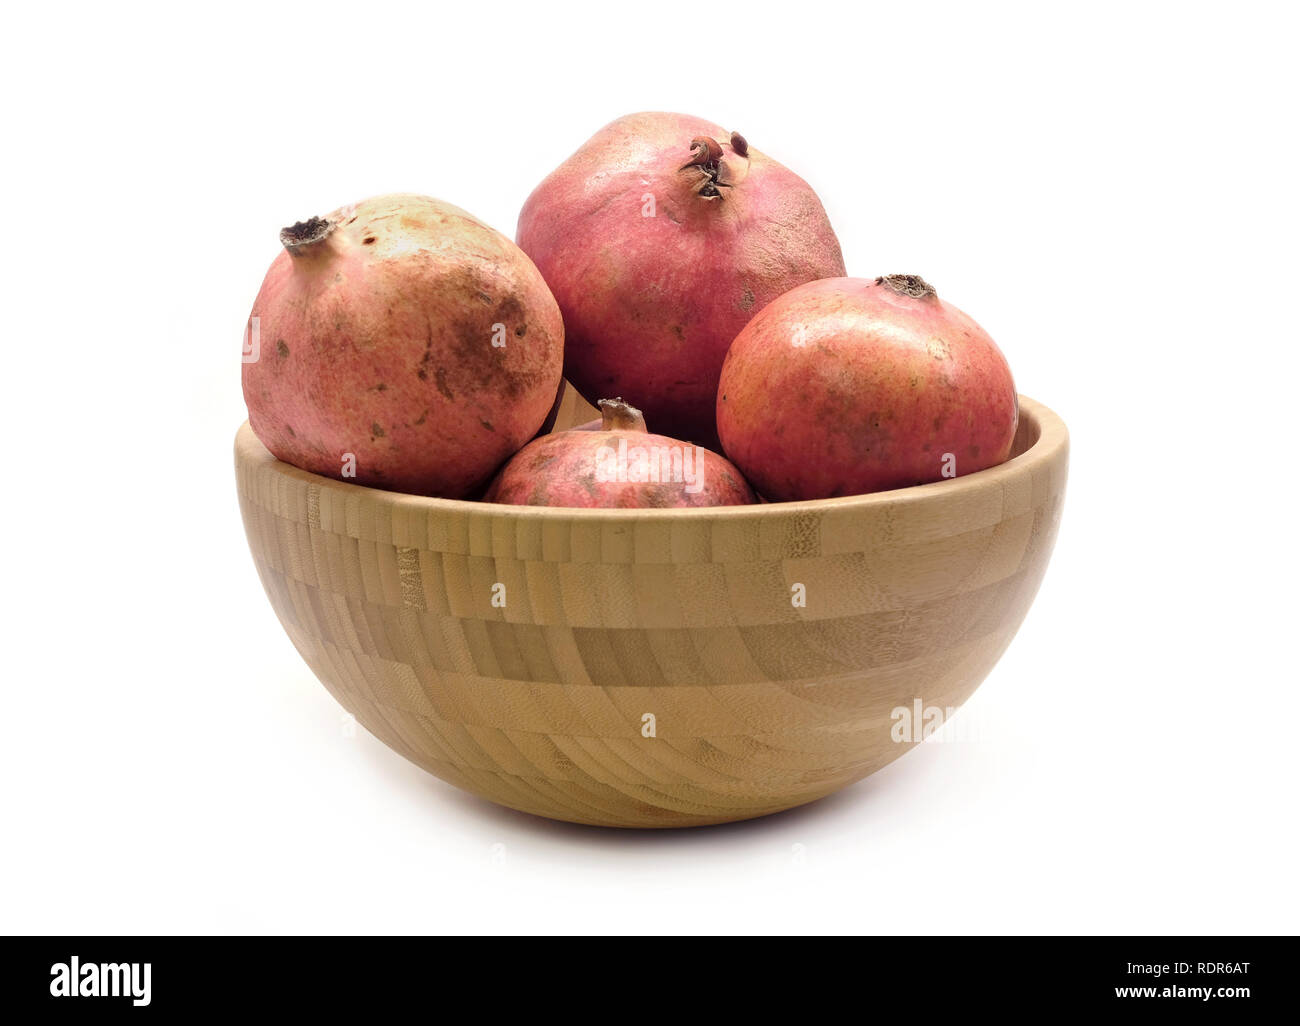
<box><xmin>243</xmin><ymin>113</ymin><xmax>1018</xmax><ymax>507</ymax></box>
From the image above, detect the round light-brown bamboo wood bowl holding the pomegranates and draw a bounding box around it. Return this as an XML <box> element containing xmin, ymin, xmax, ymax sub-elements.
<box><xmin>235</xmin><ymin>387</ymin><xmax>1069</xmax><ymax>827</ymax></box>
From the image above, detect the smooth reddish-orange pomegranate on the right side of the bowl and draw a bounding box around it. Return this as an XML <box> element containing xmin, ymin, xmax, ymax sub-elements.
<box><xmin>718</xmin><ymin>274</ymin><xmax>1019</xmax><ymax>501</ymax></box>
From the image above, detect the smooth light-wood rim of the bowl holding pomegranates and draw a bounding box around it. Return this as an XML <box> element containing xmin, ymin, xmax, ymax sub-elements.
<box><xmin>235</xmin><ymin>395</ymin><xmax>1070</xmax><ymax>521</ymax></box>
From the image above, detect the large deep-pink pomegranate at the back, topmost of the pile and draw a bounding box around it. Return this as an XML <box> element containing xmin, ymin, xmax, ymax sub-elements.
<box><xmin>516</xmin><ymin>113</ymin><xmax>845</xmax><ymax>447</ymax></box>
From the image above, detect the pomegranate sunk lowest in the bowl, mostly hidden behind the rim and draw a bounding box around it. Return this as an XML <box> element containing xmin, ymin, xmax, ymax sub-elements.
<box><xmin>484</xmin><ymin>399</ymin><xmax>757</xmax><ymax>508</ymax></box>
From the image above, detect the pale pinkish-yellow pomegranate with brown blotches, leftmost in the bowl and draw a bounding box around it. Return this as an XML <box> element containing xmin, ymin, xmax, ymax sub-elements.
<box><xmin>243</xmin><ymin>195</ymin><xmax>564</xmax><ymax>498</ymax></box>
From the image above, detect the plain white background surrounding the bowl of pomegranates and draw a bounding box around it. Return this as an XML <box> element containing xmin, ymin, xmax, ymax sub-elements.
<box><xmin>0</xmin><ymin>0</ymin><xmax>1300</xmax><ymax>932</ymax></box>
